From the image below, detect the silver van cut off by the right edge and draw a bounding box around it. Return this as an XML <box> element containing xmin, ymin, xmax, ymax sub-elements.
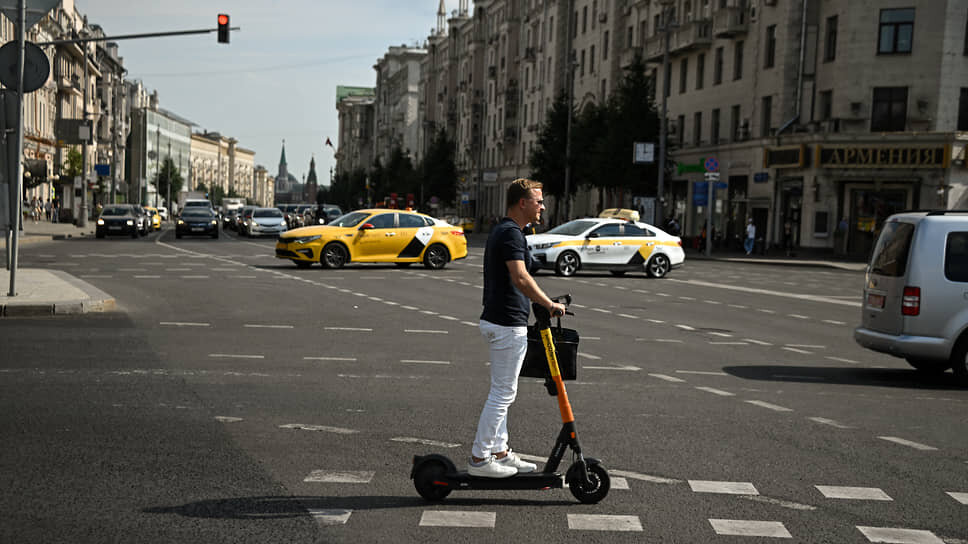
<box><xmin>854</xmin><ymin>211</ymin><xmax>968</xmax><ymax>377</ymax></box>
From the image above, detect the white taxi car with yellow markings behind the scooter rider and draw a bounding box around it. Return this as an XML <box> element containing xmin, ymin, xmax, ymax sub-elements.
<box><xmin>527</xmin><ymin>218</ymin><xmax>686</xmax><ymax>278</ymax></box>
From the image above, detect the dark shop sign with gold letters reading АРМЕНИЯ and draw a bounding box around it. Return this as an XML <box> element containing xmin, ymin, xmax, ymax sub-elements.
<box><xmin>816</xmin><ymin>144</ymin><xmax>951</xmax><ymax>168</ymax></box>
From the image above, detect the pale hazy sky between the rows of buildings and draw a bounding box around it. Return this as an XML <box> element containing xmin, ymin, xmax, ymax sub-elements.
<box><xmin>75</xmin><ymin>0</ymin><xmax>458</xmax><ymax>185</ymax></box>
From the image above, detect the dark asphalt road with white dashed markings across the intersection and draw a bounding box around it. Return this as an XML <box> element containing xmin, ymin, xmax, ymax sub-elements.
<box><xmin>0</xmin><ymin>223</ymin><xmax>968</xmax><ymax>544</ymax></box>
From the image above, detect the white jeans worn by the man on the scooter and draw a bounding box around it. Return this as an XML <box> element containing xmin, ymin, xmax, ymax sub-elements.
<box><xmin>471</xmin><ymin>319</ymin><xmax>528</xmax><ymax>459</ymax></box>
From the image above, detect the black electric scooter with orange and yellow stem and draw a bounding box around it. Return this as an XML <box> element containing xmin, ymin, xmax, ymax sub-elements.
<box><xmin>410</xmin><ymin>295</ymin><xmax>611</xmax><ymax>504</ymax></box>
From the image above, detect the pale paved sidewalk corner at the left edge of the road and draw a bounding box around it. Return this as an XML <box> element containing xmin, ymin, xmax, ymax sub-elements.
<box><xmin>0</xmin><ymin>221</ymin><xmax>117</xmax><ymax>317</ymax></box>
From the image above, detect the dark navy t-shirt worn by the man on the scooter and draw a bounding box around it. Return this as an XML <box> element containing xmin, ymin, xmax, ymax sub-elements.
<box><xmin>481</xmin><ymin>217</ymin><xmax>531</xmax><ymax>327</ymax></box>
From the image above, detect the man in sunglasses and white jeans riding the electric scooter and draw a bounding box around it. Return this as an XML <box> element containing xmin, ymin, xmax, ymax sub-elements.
<box><xmin>467</xmin><ymin>179</ymin><xmax>565</xmax><ymax>478</ymax></box>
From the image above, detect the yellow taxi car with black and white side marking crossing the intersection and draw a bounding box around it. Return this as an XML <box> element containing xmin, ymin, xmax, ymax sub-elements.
<box><xmin>276</xmin><ymin>208</ymin><xmax>467</xmax><ymax>269</ymax></box>
